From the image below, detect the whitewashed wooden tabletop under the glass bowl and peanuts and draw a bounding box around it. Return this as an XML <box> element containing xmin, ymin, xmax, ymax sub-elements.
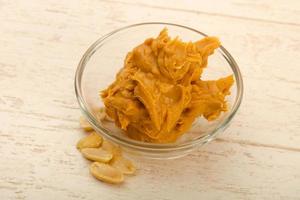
<box><xmin>0</xmin><ymin>0</ymin><xmax>300</xmax><ymax>200</ymax></box>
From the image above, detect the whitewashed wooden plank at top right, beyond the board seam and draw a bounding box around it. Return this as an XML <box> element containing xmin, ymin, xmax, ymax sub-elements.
<box><xmin>105</xmin><ymin>0</ymin><xmax>300</xmax><ymax>26</ymax></box>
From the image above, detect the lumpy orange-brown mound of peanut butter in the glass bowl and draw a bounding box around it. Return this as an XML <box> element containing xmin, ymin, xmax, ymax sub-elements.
<box><xmin>101</xmin><ymin>29</ymin><xmax>234</xmax><ymax>143</ymax></box>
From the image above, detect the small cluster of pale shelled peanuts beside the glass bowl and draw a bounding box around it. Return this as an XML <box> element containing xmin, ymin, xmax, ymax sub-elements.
<box><xmin>77</xmin><ymin>114</ymin><xmax>136</xmax><ymax>184</ymax></box>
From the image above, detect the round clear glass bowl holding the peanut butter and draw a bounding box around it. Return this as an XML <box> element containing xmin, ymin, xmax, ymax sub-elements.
<box><xmin>75</xmin><ymin>22</ymin><xmax>243</xmax><ymax>159</ymax></box>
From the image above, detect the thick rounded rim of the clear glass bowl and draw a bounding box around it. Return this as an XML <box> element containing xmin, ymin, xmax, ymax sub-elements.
<box><xmin>74</xmin><ymin>22</ymin><xmax>244</xmax><ymax>151</ymax></box>
